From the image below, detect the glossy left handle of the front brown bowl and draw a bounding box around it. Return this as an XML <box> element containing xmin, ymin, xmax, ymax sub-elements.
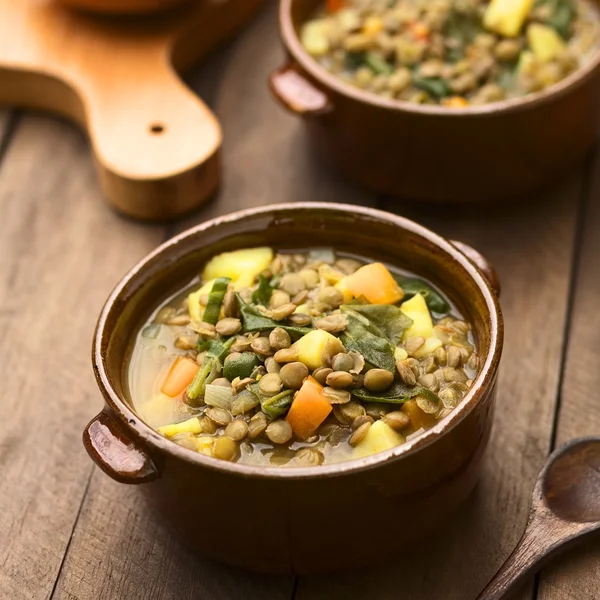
<box><xmin>83</xmin><ymin>408</ymin><xmax>159</xmax><ymax>483</ymax></box>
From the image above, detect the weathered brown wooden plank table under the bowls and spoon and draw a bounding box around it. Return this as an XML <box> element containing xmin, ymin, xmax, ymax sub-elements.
<box><xmin>0</xmin><ymin>4</ymin><xmax>600</xmax><ymax>600</ymax></box>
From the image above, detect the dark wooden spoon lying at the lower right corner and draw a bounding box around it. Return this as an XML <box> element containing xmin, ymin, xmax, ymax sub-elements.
<box><xmin>477</xmin><ymin>437</ymin><xmax>600</xmax><ymax>600</ymax></box>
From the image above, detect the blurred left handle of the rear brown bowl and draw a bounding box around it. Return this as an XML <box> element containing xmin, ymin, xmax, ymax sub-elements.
<box><xmin>269</xmin><ymin>63</ymin><xmax>333</xmax><ymax>117</ymax></box>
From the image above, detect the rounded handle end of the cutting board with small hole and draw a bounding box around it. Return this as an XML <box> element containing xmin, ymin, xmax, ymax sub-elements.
<box><xmin>76</xmin><ymin>55</ymin><xmax>222</xmax><ymax>219</ymax></box>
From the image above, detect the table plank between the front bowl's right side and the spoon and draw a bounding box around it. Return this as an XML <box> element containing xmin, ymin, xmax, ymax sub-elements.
<box><xmin>297</xmin><ymin>173</ymin><xmax>581</xmax><ymax>600</ymax></box>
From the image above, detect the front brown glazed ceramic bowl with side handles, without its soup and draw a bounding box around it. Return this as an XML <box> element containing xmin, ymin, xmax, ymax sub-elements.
<box><xmin>84</xmin><ymin>203</ymin><xmax>503</xmax><ymax>573</ymax></box>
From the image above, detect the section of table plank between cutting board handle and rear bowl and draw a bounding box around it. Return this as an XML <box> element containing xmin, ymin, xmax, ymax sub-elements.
<box><xmin>179</xmin><ymin>2</ymin><xmax>375</xmax><ymax>228</ymax></box>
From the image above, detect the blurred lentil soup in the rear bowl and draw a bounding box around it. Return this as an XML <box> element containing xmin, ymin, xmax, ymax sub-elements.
<box><xmin>300</xmin><ymin>0</ymin><xmax>600</xmax><ymax>108</ymax></box>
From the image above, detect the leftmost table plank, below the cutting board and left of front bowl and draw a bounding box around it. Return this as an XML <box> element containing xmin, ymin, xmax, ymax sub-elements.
<box><xmin>0</xmin><ymin>117</ymin><xmax>163</xmax><ymax>600</ymax></box>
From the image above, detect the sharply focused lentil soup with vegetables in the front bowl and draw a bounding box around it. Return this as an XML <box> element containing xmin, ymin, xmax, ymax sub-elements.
<box><xmin>128</xmin><ymin>248</ymin><xmax>479</xmax><ymax>466</ymax></box>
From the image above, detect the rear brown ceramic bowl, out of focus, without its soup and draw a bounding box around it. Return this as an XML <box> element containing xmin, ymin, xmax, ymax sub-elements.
<box><xmin>270</xmin><ymin>0</ymin><xmax>600</xmax><ymax>201</ymax></box>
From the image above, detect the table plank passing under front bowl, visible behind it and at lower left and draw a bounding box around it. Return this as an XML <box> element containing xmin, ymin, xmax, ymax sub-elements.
<box><xmin>55</xmin><ymin>4</ymin><xmax>375</xmax><ymax>600</ymax></box>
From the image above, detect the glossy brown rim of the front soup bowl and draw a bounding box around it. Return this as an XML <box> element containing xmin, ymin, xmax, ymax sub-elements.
<box><xmin>92</xmin><ymin>202</ymin><xmax>504</xmax><ymax>479</ymax></box>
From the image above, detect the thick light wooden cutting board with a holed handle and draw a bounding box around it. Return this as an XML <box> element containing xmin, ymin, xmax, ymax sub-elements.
<box><xmin>0</xmin><ymin>0</ymin><xmax>263</xmax><ymax>220</ymax></box>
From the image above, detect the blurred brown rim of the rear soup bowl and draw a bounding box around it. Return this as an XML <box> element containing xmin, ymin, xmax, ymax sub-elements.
<box><xmin>279</xmin><ymin>0</ymin><xmax>600</xmax><ymax>117</ymax></box>
